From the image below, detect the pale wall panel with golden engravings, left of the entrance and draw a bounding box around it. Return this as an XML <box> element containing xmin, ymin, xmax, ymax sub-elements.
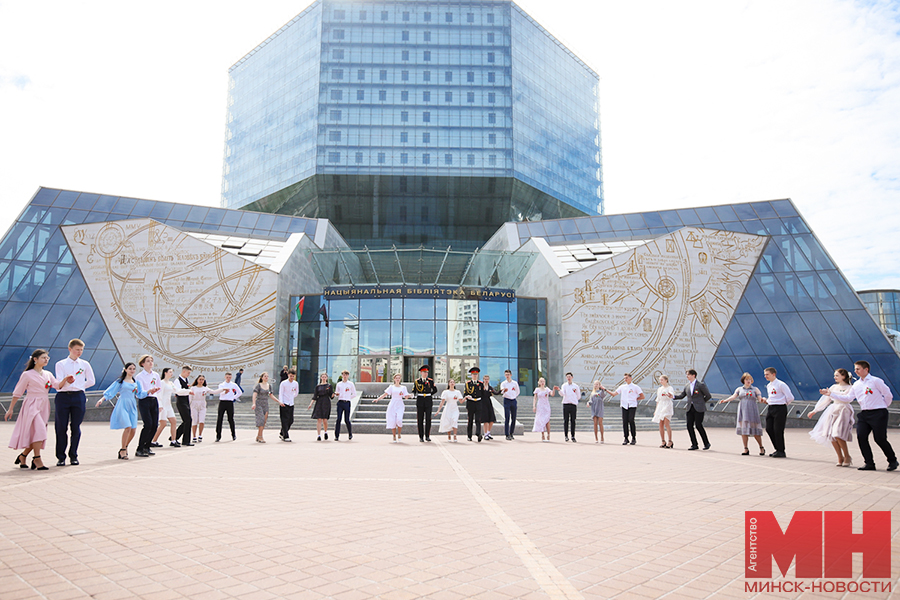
<box><xmin>64</xmin><ymin>219</ymin><xmax>277</xmax><ymax>371</ymax></box>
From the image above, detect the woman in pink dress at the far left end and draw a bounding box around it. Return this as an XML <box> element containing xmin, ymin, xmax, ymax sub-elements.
<box><xmin>6</xmin><ymin>350</ymin><xmax>75</xmax><ymax>471</ymax></box>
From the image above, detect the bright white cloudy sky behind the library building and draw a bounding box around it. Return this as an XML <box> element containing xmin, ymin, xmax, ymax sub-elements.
<box><xmin>0</xmin><ymin>0</ymin><xmax>900</xmax><ymax>290</ymax></box>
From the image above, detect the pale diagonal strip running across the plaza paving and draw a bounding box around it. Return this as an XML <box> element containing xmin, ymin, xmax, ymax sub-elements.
<box><xmin>437</xmin><ymin>442</ymin><xmax>584</xmax><ymax>600</ymax></box>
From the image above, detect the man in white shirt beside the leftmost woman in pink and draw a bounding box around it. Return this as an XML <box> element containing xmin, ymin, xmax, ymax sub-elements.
<box><xmin>54</xmin><ymin>338</ymin><xmax>96</xmax><ymax>467</ymax></box>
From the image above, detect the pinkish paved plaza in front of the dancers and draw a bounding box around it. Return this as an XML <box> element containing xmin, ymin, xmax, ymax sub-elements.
<box><xmin>0</xmin><ymin>423</ymin><xmax>900</xmax><ymax>600</ymax></box>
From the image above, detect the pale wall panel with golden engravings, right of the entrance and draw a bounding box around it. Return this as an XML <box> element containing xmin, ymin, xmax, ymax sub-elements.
<box><xmin>562</xmin><ymin>227</ymin><xmax>767</xmax><ymax>387</ymax></box>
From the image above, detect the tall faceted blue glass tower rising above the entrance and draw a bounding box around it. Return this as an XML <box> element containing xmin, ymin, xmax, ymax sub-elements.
<box><xmin>222</xmin><ymin>0</ymin><xmax>602</xmax><ymax>249</ymax></box>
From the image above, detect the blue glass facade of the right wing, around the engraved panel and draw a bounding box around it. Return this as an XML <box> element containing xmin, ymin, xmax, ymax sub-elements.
<box><xmin>515</xmin><ymin>200</ymin><xmax>900</xmax><ymax>399</ymax></box>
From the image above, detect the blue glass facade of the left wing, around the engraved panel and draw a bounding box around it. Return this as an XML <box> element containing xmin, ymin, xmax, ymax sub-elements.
<box><xmin>0</xmin><ymin>188</ymin><xmax>316</xmax><ymax>392</ymax></box>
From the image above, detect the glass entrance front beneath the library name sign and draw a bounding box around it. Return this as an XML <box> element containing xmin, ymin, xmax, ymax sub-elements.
<box><xmin>291</xmin><ymin>296</ymin><xmax>548</xmax><ymax>394</ymax></box>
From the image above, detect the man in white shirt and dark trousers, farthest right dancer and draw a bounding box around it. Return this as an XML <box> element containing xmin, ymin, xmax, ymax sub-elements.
<box><xmin>819</xmin><ymin>360</ymin><xmax>898</xmax><ymax>471</ymax></box>
